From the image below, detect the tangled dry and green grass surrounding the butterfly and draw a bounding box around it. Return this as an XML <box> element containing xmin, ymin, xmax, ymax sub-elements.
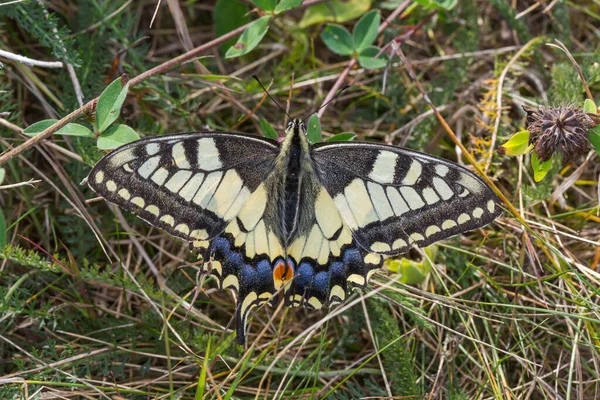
<box><xmin>0</xmin><ymin>0</ymin><xmax>600</xmax><ymax>399</ymax></box>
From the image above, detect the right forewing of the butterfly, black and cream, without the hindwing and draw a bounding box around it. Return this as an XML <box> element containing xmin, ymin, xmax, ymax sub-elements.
<box><xmin>312</xmin><ymin>143</ymin><xmax>501</xmax><ymax>255</ymax></box>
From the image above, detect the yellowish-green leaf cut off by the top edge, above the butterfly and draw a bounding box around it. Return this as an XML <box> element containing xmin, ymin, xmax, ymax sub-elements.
<box><xmin>298</xmin><ymin>0</ymin><xmax>372</xmax><ymax>29</ymax></box>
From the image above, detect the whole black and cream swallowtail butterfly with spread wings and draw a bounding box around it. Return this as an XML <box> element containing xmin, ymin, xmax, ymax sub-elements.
<box><xmin>87</xmin><ymin>119</ymin><xmax>501</xmax><ymax>344</ymax></box>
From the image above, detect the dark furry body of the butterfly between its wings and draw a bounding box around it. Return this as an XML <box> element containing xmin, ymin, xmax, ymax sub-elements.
<box><xmin>267</xmin><ymin>119</ymin><xmax>318</xmax><ymax>244</ymax></box>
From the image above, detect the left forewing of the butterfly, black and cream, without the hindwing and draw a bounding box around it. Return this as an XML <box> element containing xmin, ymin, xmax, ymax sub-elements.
<box><xmin>88</xmin><ymin>132</ymin><xmax>279</xmax><ymax>241</ymax></box>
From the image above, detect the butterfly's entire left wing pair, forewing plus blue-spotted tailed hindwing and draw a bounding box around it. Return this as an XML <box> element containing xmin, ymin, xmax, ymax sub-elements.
<box><xmin>88</xmin><ymin>132</ymin><xmax>291</xmax><ymax>343</ymax></box>
